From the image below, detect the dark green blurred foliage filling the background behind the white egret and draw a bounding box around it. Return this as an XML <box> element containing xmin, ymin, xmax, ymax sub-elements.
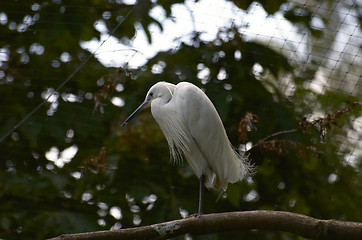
<box><xmin>0</xmin><ymin>0</ymin><xmax>362</xmax><ymax>239</ymax></box>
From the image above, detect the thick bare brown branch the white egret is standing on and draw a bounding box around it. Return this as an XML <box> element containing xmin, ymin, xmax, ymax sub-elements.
<box><xmin>51</xmin><ymin>211</ymin><xmax>362</xmax><ymax>240</ymax></box>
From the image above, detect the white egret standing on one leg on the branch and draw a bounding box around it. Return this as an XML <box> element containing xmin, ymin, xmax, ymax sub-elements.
<box><xmin>122</xmin><ymin>82</ymin><xmax>252</xmax><ymax>214</ymax></box>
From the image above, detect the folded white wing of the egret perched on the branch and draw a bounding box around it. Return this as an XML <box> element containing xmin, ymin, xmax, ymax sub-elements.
<box><xmin>172</xmin><ymin>82</ymin><xmax>249</xmax><ymax>190</ymax></box>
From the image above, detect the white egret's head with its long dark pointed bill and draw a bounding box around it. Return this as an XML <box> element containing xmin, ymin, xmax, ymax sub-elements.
<box><xmin>121</xmin><ymin>82</ymin><xmax>176</xmax><ymax>126</ymax></box>
